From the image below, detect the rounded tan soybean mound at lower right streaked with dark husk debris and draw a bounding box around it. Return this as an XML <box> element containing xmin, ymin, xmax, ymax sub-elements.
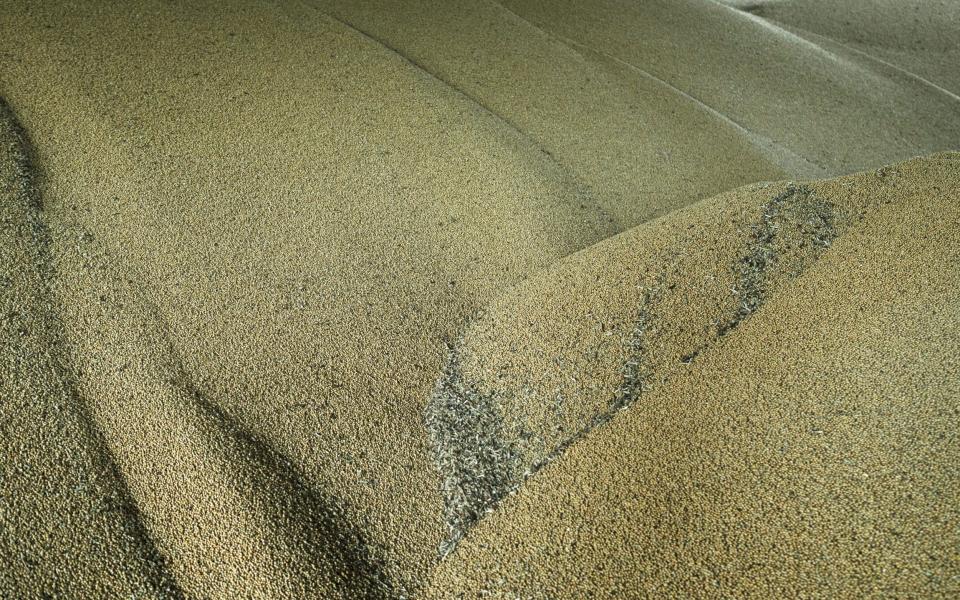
<box><xmin>428</xmin><ymin>154</ymin><xmax>960</xmax><ymax>598</ymax></box>
